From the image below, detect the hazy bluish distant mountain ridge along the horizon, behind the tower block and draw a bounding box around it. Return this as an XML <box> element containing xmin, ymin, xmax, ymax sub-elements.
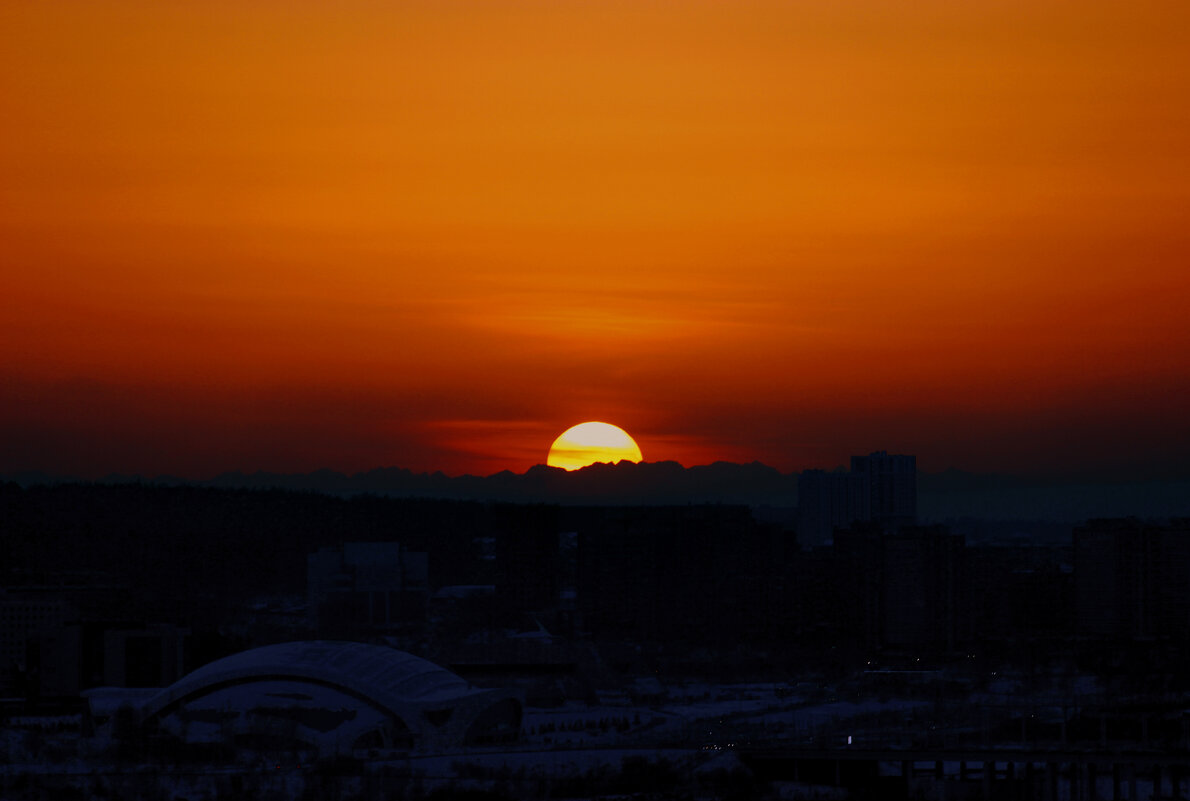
<box><xmin>0</xmin><ymin>462</ymin><xmax>1190</xmax><ymax>522</ymax></box>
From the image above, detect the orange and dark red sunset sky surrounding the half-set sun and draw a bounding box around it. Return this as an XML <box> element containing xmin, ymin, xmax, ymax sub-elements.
<box><xmin>0</xmin><ymin>0</ymin><xmax>1190</xmax><ymax>477</ymax></box>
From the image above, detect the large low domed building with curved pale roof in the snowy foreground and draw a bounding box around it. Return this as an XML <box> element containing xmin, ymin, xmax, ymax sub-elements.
<box><xmin>140</xmin><ymin>642</ymin><xmax>521</xmax><ymax>753</ymax></box>
